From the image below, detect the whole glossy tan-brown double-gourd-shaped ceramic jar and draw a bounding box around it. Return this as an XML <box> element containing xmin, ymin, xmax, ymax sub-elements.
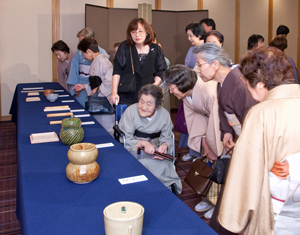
<box><xmin>66</xmin><ymin>143</ymin><xmax>100</xmax><ymax>184</ymax></box>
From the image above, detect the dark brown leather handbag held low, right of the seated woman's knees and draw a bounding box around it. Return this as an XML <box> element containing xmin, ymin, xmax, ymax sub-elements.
<box><xmin>184</xmin><ymin>158</ymin><xmax>212</xmax><ymax>196</ymax></box>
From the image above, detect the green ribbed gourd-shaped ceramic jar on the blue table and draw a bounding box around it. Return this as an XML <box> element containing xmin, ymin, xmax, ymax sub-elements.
<box><xmin>59</xmin><ymin>116</ymin><xmax>84</xmax><ymax>145</ymax></box>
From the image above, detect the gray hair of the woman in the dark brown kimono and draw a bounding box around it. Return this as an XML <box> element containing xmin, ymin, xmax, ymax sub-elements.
<box><xmin>193</xmin><ymin>43</ymin><xmax>232</xmax><ymax>67</ymax></box>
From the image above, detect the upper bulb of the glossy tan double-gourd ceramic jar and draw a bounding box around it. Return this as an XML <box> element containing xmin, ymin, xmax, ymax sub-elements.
<box><xmin>67</xmin><ymin>143</ymin><xmax>98</xmax><ymax>165</ymax></box>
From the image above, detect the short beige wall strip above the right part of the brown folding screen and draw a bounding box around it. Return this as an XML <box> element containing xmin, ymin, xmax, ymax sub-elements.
<box><xmin>161</xmin><ymin>0</ymin><xmax>198</xmax><ymax>11</ymax></box>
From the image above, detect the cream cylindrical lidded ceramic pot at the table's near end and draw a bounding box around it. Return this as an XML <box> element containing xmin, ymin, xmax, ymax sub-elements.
<box><xmin>103</xmin><ymin>202</ymin><xmax>145</xmax><ymax>235</ymax></box>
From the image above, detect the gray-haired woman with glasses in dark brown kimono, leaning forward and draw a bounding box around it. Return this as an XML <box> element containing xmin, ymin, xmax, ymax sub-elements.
<box><xmin>194</xmin><ymin>43</ymin><xmax>257</xmax><ymax>151</ymax></box>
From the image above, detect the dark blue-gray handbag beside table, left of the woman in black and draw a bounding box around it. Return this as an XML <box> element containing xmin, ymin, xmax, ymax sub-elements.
<box><xmin>85</xmin><ymin>87</ymin><xmax>115</xmax><ymax>114</ymax></box>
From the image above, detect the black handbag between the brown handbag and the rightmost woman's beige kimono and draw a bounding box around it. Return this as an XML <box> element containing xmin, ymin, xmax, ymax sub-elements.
<box><xmin>210</xmin><ymin>147</ymin><xmax>233</xmax><ymax>184</ymax></box>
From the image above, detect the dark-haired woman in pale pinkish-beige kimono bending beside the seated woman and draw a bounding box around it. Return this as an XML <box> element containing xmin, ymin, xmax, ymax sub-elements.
<box><xmin>164</xmin><ymin>64</ymin><xmax>223</xmax><ymax>218</ymax></box>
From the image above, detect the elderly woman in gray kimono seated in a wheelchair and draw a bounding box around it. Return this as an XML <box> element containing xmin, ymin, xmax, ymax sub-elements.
<box><xmin>119</xmin><ymin>84</ymin><xmax>182</xmax><ymax>194</ymax></box>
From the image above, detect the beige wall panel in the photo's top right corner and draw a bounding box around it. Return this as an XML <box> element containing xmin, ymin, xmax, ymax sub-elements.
<box><xmin>273</xmin><ymin>0</ymin><xmax>298</xmax><ymax>64</ymax></box>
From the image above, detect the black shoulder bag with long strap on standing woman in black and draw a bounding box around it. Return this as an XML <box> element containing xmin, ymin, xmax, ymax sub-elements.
<box><xmin>118</xmin><ymin>47</ymin><xmax>136</xmax><ymax>93</ymax></box>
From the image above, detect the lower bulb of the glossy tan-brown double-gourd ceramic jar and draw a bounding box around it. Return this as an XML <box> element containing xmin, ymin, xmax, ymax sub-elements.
<box><xmin>66</xmin><ymin>161</ymin><xmax>100</xmax><ymax>184</ymax></box>
